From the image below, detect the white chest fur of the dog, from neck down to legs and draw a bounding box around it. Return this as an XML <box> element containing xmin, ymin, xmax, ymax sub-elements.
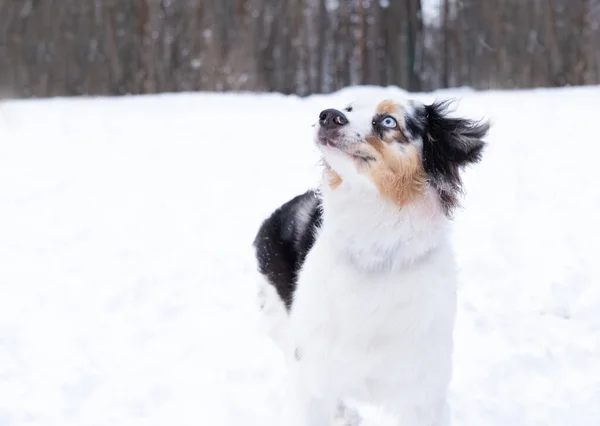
<box><xmin>290</xmin><ymin>185</ymin><xmax>456</xmax><ymax>426</ymax></box>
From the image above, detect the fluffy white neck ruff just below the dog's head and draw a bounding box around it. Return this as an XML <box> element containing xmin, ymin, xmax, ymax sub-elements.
<box><xmin>319</xmin><ymin>178</ymin><xmax>448</xmax><ymax>272</ymax></box>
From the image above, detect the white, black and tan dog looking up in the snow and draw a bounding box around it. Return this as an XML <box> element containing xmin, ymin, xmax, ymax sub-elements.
<box><xmin>254</xmin><ymin>94</ymin><xmax>489</xmax><ymax>426</ymax></box>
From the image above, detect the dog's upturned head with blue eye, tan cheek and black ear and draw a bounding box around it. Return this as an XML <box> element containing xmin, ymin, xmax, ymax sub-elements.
<box><xmin>316</xmin><ymin>100</ymin><xmax>489</xmax><ymax>215</ymax></box>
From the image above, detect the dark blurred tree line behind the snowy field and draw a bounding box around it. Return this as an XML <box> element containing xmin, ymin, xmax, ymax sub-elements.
<box><xmin>0</xmin><ymin>0</ymin><xmax>600</xmax><ymax>97</ymax></box>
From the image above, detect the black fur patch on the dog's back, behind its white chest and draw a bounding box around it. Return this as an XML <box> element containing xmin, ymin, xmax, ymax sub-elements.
<box><xmin>254</xmin><ymin>190</ymin><xmax>322</xmax><ymax>310</ymax></box>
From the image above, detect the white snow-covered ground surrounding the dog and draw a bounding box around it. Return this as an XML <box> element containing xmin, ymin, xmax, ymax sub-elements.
<box><xmin>0</xmin><ymin>88</ymin><xmax>600</xmax><ymax>426</ymax></box>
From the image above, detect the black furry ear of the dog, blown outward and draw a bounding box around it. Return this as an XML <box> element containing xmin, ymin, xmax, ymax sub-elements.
<box><xmin>422</xmin><ymin>101</ymin><xmax>490</xmax><ymax>216</ymax></box>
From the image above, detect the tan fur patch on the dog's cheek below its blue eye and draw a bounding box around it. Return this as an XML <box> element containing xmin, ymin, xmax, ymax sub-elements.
<box><xmin>366</xmin><ymin>136</ymin><xmax>425</xmax><ymax>207</ymax></box>
